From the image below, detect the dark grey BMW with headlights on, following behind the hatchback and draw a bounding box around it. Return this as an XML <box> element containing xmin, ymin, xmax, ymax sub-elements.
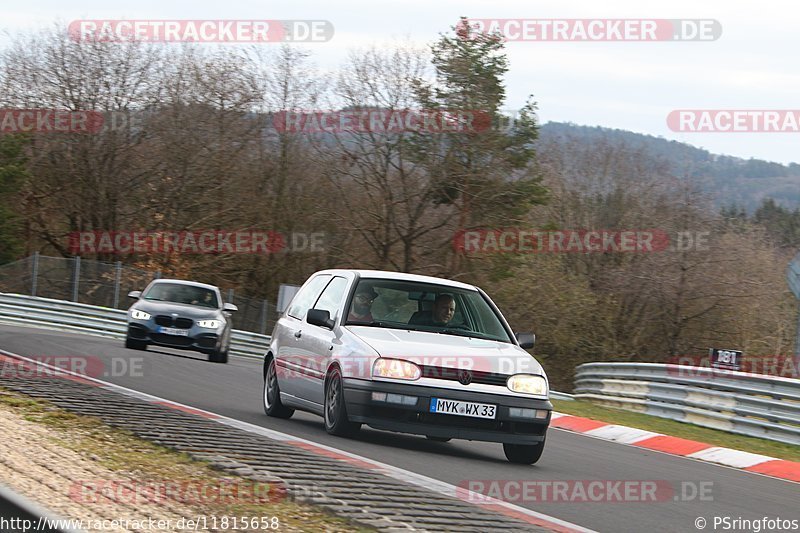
<box><xmin>125</xmin><ymin>279</ymin><xmax>238</xmax><ymax>363</ymax></box>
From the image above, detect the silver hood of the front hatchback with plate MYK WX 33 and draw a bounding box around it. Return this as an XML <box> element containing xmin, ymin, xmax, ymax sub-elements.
<box><xmin>347</xmin><ymin>326</ymin><xmax>544</xmax><ymax>375</ymax></box>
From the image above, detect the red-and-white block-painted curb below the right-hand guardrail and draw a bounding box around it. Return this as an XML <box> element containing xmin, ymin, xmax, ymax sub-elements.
<box><xmin>550</xmin><ymin>413</ymin><xmax>800</xmax><ymax>482</ymax></box>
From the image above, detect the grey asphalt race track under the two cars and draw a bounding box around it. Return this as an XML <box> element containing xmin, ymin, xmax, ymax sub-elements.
<box><xmin>0</xmin><ymin>325</ymin><xmax>800</xmax><ymax>532</ymax></box>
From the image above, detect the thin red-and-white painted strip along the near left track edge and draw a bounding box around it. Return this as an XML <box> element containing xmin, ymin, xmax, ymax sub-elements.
<box><xmin>0</xmin><ymin>350</ymin><xmax>595</xmax><ymax>533</ymax></box>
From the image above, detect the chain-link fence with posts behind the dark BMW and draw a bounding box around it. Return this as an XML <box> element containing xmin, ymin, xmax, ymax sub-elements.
<box><xmin>0</xmin><ymin>253</ymin><xmax>277</xmax><ymax>334</ymax></box>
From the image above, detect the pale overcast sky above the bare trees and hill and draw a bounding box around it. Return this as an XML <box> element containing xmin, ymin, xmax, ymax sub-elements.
<box><xmin>0</xmin><ymin>0</ymin><xmax>800</xmax><ymax>163</ymax></box>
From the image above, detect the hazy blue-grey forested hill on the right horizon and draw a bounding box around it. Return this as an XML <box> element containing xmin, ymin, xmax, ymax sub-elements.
<box><xmin>538</xmin><ymin>122</ymin><xmax>800</xmax><ymax>213</ymax></box>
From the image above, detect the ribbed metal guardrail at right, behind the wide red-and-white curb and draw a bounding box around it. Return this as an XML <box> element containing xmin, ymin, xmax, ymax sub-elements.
<box><xmin>574</xmin><ymin>363</ymin><xmax>800</xmax><ymax>445</ymax></box>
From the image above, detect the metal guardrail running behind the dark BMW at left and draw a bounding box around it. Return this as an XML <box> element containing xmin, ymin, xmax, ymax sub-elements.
<box><xmin>0</xmin><ymin>293</ymin><xmax>270</xmax><ymax>359</ymax></box>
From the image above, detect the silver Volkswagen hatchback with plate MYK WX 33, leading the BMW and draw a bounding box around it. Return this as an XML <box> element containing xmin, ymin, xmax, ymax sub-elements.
<box><xmin>263</xmin><ymin>270</ymin><xmax>553</xmax><ymax>464</ymax></box>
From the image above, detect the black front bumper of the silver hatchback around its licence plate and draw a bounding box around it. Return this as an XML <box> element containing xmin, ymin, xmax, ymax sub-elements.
<box><xmin>344</xmin><ymin>379</ymin><xmax>553</xmax><ymax>444</ymax></box>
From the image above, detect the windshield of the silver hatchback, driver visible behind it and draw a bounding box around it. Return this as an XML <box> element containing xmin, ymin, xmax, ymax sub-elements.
<box><xmin>345</xmin><ymin>278</ymin><xmax>512</xmax><ymax>342</ymax></box>
